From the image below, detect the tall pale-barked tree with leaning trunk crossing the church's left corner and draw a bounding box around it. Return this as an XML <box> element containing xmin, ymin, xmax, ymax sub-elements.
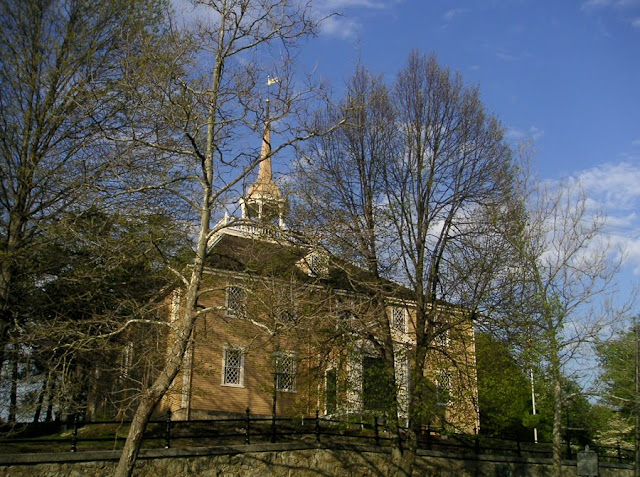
<box><xmin>114</xmin><ymin>0</ymin><xmax>324</xmax><ymax>476</ymax></box>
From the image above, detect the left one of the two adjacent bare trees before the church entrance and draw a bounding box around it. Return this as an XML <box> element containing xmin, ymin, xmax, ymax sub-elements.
<box><xmin>297</xmin><ymin>66</ymin><xmax>412</xmax><ymax>468</ymax></box>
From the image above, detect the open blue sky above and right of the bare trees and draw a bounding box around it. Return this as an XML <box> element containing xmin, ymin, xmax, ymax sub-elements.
<box><xmin>301</xmin><ymin>0</ymin><xmax>640</xmax><ymax>280</ymax></box>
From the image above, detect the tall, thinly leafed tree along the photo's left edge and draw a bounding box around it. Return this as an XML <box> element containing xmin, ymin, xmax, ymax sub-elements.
<box><xmin>0</xmin><ymin>0</ymin><xmax>168</xmax><ymax>424</ymax></box>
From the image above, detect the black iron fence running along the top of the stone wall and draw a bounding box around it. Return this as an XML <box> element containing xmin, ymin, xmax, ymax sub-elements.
<box><xmin>0</xmin><ymin>409</ymin><xmax>634</xmax><ymax>462</ymax></box>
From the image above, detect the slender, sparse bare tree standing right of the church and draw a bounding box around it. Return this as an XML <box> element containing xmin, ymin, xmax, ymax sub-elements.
<box><xmin>511</xmin><ymin>180</ymin><xmax>632</xmax><ymax>476</ymax></box>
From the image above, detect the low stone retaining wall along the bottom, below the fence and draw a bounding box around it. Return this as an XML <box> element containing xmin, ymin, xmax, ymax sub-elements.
<box><xmin>0</xmin><ymin>443</ymin><xmax>633</xmax><ymax>477</ymax></box>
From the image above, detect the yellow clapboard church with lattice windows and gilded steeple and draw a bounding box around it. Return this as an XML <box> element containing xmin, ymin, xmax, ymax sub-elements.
<box><xmin>163</xmin><ymin>112</ymin><xmax>478</xmax><ymax>432</ymax></box>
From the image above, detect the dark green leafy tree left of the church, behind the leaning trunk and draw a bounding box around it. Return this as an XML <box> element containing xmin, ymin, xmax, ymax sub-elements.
<box><xmin>4</xmin><ymin>208</ymin><xmax>187</xmax><ymax>419</ymax></box>
